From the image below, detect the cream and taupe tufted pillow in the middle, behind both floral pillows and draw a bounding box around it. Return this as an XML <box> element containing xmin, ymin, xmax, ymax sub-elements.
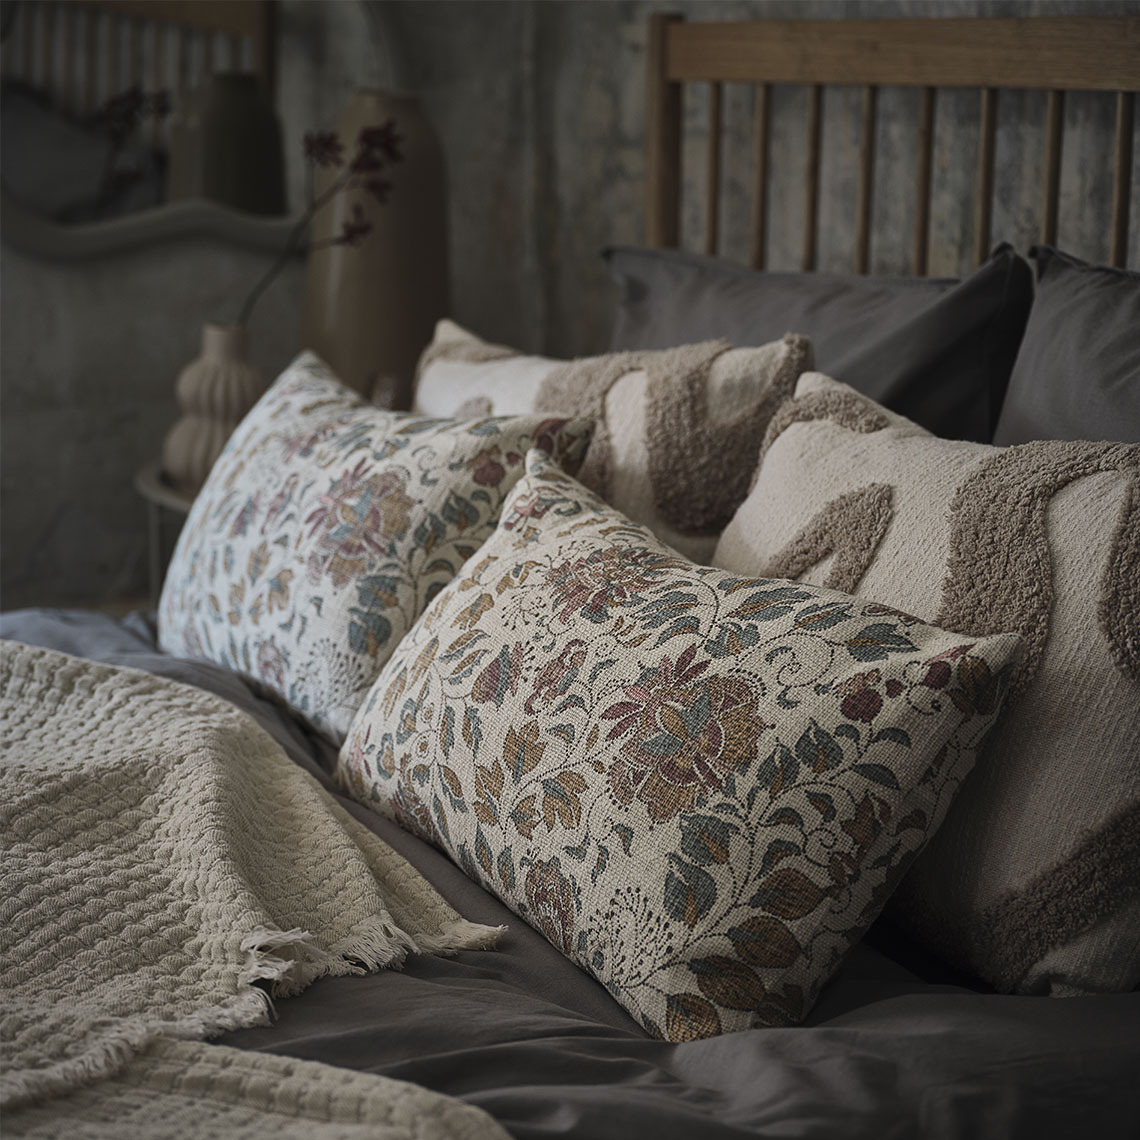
<box><xmin>415</xmin><ymin>321</ymin><xmax>812</xmax><ymax>562</ymax></box>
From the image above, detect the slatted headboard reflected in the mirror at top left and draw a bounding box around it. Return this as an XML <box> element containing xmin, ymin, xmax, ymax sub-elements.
<box><xmin>3</xmin><ymin>0</ymin><xmax>275</xmax><ymax>123</ymax></box>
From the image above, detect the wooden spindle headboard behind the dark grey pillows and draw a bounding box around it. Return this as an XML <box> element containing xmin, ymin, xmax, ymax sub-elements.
<box><xmin>645</xmin><ymin>14</ymin><xmax>1140</xmax><ymax>276</ymax></box>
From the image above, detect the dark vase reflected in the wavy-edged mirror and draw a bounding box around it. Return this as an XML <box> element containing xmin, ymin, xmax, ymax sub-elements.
<box><xmin>166</xmin><ymin>72</ymin><xmax>285</xmax><ymax>215</ymax></box>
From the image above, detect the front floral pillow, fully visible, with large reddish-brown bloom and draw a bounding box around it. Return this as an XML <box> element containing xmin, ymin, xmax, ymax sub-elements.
<box><xmin>337</xmin><ymin>451</ymin><xmax>1020</xmax><ymax>1041</ymax></box>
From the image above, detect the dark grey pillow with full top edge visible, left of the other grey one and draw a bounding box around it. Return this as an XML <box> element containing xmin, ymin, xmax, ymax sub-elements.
<box><xmin>605</xmin><ymin>245</ymin><xmax>1033</xmax><ymax>442</ymax></box>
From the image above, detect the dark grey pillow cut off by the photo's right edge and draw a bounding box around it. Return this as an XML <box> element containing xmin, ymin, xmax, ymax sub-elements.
<box><xmin>994</xmin><ymin>245</ymin><xmax>1140</xmax><ymax>445</ymax></box>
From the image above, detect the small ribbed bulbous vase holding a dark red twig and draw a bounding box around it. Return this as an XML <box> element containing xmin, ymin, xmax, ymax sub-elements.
<box><xmin>162</xmin><ymin>324</ymin><xmax>266</xmax><ymax>497</ymax></box>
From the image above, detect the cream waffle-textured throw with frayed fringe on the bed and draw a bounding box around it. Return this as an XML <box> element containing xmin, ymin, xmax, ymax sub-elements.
<box><xmin>0</xmin><ymin>642</ymin><xmax>503</xmax><ymax>1140</ymax></box>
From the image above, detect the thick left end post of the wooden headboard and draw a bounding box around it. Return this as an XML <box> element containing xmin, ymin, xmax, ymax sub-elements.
<box><xmin>645</xmin><ymin>13</ymin><xmax>681</xmax><ymax>249</ymax></box>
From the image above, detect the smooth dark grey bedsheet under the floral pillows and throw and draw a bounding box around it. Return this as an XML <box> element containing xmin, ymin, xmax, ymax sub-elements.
<box><xmin>0</xmin><ymin>610</ymin><xmax>1140</xmax><ymax>1140</ymax></box>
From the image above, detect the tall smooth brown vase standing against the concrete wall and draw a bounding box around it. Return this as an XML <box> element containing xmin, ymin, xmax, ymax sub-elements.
<box><xmin>301</xmin><ymin>90</ymin><xmax>449</xmax><ymax>408</ymax></box>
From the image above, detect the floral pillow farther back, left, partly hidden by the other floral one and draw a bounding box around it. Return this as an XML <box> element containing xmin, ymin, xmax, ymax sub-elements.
<box><xmin>158</xmin><ymin>352</ymin><xmax>589</xmax><ymax>743</ymax></box>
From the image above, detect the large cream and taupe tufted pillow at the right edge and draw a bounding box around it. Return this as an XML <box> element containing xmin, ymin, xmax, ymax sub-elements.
<box><xmin>715</xmin><ymin>374</ymin><xmax>1140</xmax><ymax>995</ymax></box>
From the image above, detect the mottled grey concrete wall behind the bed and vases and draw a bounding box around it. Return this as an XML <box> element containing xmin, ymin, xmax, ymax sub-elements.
<box><xmin>0</xmin><ymin>0</ymin><xmax>1140</xmax><ymax>608</ymax></box>
